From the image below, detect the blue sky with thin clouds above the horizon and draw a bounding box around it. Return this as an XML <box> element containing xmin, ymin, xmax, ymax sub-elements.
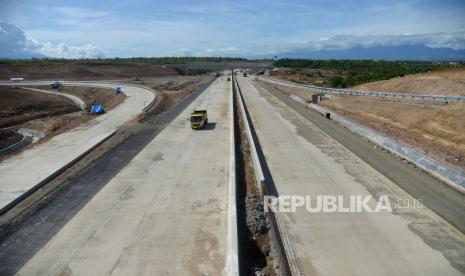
<box><xmin>0</xmin><ymin>0</ymin><xmax>465</xmax><ymax>57</ymax></box>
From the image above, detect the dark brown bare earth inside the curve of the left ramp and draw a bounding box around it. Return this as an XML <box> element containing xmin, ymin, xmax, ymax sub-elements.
<box><xmin>0</xmin><ymin>86</ymin><xmax>125</xmax><ymax>159</ymax></box>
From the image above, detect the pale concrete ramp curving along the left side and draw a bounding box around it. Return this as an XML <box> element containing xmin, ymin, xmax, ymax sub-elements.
<box><xmin>0</xmin><ymin>82</ymin><xmax>155</xmax><ymax>210</ymax></box>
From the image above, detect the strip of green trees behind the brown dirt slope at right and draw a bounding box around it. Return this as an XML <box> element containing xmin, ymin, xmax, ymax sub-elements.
<box><xmin>274</xmin><ymin>59</ymin><xmax>455</xmax><ymax>88</ymax></box>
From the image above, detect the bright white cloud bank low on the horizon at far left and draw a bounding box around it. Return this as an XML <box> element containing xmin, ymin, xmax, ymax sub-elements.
<box><xmin>0</xmin><ymin>22</ymin><xmax>106</xmax><ymax>58</ymax></box>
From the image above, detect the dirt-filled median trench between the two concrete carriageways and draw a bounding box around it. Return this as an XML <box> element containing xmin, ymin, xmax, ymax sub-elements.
<box><xmin>233</xmin><ymin>75</ymin><xmax>296</xmax><ymax>275</ymax></box>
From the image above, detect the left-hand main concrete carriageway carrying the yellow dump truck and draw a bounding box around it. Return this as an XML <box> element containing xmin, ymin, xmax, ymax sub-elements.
<box><xmin>18</xmin><ymin>78</ymin><xmax>232</xmax><ymax>275</ymax></box>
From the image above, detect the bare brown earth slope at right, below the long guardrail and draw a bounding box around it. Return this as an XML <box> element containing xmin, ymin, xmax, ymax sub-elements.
<box><xmin>321</xmin><ymin>97</ymin><xmax>465</xmax><ymax>169</ymax></box>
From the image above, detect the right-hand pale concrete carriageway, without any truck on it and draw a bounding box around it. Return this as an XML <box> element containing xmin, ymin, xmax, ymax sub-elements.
<box><xmin>238</xmin><ymin>77</ymin><xmax>465</xmax><ymax>276</ymax></box>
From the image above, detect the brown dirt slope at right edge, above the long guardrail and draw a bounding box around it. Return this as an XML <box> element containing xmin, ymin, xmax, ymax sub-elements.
<box><xmin>354</xmin><ymin>67</ymin><xmax>465</xmax><ymax>96</ymax></box>
